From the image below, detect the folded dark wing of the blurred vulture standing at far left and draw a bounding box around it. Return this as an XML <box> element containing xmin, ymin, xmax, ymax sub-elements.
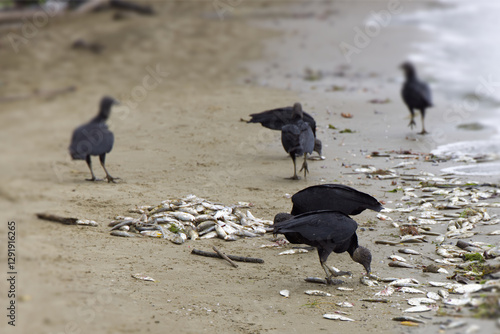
<box><xmin>69</xmin><ymin>123</ymin><xmax>114</xmax><ymax>159</ymax></box>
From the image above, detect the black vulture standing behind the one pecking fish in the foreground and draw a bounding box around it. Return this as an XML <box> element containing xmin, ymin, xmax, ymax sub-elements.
<box><xmin>291</xmin><ymin>184</ymin><xmax>383</xmax><ymax>216</ymax></box>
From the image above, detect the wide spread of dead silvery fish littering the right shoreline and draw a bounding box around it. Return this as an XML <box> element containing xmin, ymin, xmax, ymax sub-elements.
<box><xmin>368</xmin><ymin>173</ymin><xmax>500</xmax><ymax>326</ymax></box>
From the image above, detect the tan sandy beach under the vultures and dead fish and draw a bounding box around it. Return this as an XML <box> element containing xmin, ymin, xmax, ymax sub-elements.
<box><xmin>0</xmin><ymin>1</ymin><xmax>500</xmax><ymax>333</ymax></box>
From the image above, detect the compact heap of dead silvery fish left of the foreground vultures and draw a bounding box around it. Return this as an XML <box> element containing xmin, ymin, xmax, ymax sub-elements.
<box><xmin>109</xmin><ymin>195</ymin><xmax>273</xmax><ymax>244</ymax></box>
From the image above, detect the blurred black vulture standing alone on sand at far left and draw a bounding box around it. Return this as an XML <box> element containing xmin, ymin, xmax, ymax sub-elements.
<box><xmin>69</xmin><ymin>96</ymin><xmax>119</xmax><ymax>182</ymax></box>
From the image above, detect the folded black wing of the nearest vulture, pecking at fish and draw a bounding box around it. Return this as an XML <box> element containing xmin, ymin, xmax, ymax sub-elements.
<box><xmin>273</xmin><ymin>211</ymin><xmax>358</xmax><ymax>244</ymax></box>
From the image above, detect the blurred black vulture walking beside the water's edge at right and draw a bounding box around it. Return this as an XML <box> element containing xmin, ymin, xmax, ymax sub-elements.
<box><xmin>401</xmin><ymin>62</ymin><xmax>432</xmax><ymax>135</ymax></box>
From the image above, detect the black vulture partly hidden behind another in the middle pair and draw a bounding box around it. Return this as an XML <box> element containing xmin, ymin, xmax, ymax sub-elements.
<box><xmin>247</xmin><ymin>103</ymin><xmax>323</xmax><ymax>157</ymax></box>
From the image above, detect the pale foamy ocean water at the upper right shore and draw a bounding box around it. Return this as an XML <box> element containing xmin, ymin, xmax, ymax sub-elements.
<box><xmin>393</xmin><ymin>0</ymin><xmax>500</xmax><ymax>175</ymax></box>
